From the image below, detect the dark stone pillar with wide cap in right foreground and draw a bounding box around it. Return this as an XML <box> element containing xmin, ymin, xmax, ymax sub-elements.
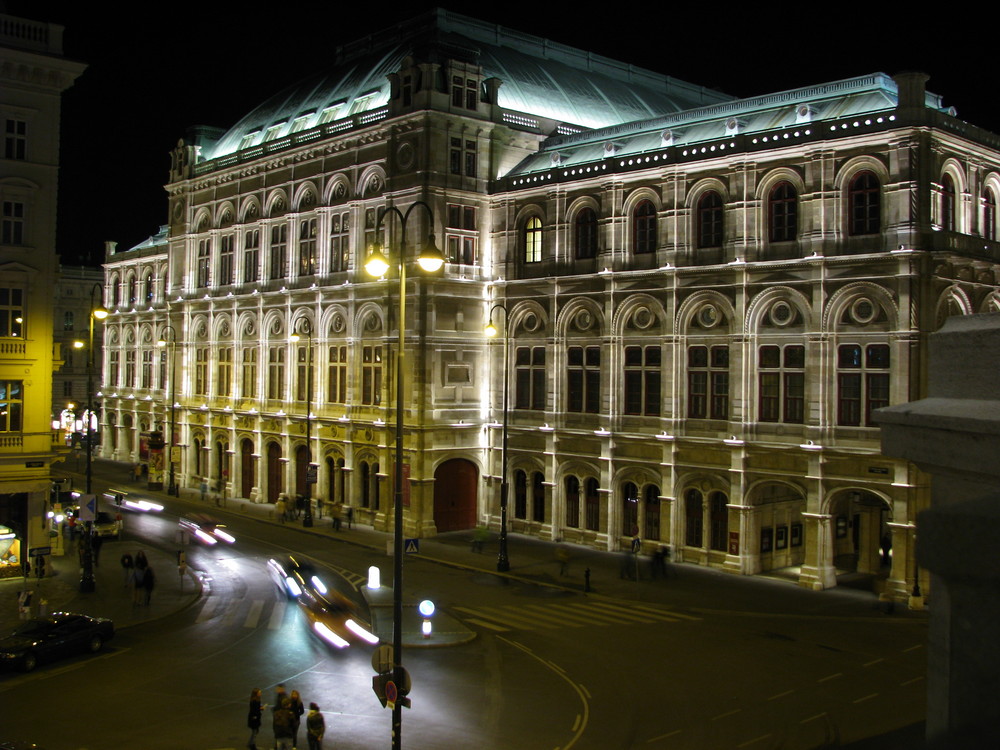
<box><xmin>878</xmin><ymin>314</ymin><xmax>1000</xmax><ymax>748</ymax></box>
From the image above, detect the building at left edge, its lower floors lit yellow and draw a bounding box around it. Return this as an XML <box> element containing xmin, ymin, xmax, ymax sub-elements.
<box><xmin>0</xmin><ymin>14</ymin><xmax>84</xmax><ymax>577</ymax></box>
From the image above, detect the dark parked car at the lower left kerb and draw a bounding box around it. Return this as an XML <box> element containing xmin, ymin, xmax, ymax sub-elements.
<box><xmin>0</xmin><ymin>612</ymin><xmax>115</xmax><ymax>672</ymax></box>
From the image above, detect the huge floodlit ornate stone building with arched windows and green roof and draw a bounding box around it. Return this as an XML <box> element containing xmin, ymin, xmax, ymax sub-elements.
<box><xmin>102</xmin><ymin>11</ymin><xmax>1000</xmax><ymax>597</ymax></box>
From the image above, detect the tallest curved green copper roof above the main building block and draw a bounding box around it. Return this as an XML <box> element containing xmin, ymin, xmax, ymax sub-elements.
<box><xmin>203</xmin><ymin>10</ymin><xmax>731</xmax><ymax>159</ymax></box>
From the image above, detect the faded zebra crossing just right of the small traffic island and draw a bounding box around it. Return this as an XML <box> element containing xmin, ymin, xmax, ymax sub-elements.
<box><xmin>455</xmin><ymin>599</ymin><xmax>701</xmax><ymax>633</ymax></box>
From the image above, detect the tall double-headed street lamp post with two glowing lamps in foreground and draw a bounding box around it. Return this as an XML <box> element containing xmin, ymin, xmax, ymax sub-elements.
<box><xmin>365</xmin><ymin>201</ymin><xmax>444</xmax><ymax>750</ymax></box>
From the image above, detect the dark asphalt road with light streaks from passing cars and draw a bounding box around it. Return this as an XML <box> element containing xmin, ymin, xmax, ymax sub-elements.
<box><xmin>0</xmin><ymin>464</ymin><xmax>926</xmax><ymax>750</ymax></box>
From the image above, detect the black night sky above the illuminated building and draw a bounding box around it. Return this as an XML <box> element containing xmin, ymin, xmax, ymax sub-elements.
<box><xmin>11</xmin><ymin>0</ymin><xmax>988</xmax><ymax>263</ymax></box>
